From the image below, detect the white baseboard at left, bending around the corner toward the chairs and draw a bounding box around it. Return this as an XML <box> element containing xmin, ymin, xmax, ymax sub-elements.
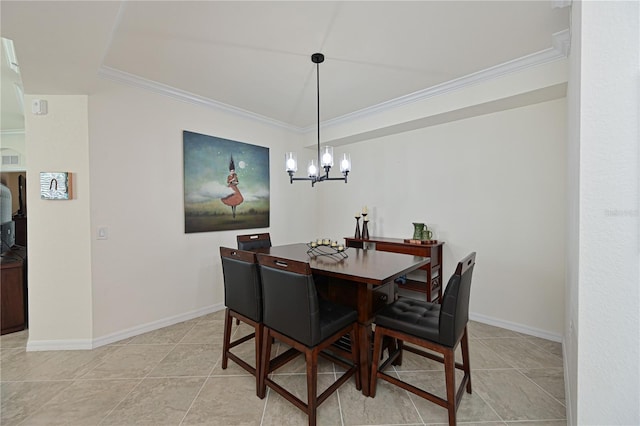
<box><xmin>27</xmin><ymin>303</ymin><xmax>224</xmax><ymax>352</ymax></box>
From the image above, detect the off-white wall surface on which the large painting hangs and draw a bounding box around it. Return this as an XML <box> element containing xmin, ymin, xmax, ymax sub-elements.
<box><xmin>89</xmin><ymin>81</ymin><xmax>315</xmax><ymax>343</ymax></box>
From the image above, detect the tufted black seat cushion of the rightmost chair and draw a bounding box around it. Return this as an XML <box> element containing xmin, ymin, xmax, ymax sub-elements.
<box><xmin>375</xmin><ymin>297</ymin><xmax>440</xmax><ymax>342</ymax></box>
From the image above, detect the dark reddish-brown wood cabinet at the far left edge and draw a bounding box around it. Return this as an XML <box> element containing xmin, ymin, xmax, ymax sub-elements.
<box><xmin>0</xmin><ymin>248</ymin><xmax>27</xmax><ymax>334</ymax></box>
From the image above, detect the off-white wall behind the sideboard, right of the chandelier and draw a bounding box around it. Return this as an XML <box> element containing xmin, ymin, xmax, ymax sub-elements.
<box><xmin>320</xmin><ymin>99</ymin><xmax>566</xmax><ymax>341</ymax></box>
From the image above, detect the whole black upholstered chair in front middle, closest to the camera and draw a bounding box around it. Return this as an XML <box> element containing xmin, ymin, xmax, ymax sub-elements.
<box><xmin>258</xmin><ymin>254</ymin><xmax>362</xmax><ymax>425</ymax></box>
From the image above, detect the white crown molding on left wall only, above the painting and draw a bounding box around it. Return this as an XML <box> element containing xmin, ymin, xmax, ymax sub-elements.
<box><xmin>98</xmin><ymin>65</ymin><xmax>300</xmax><ymax>132</ymax></box>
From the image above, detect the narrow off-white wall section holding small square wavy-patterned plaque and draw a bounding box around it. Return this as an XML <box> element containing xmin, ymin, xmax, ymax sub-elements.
<box><xmin>25</xmin><ymin>96</ymin><xmax>93</xmax><ymax>350</ymax></box>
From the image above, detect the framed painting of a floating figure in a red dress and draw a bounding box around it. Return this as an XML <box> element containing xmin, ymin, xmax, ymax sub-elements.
<box><xmin>183</xmin><ymin>130</ymin><xmax>269</xmax><ymax>234</ymax></box>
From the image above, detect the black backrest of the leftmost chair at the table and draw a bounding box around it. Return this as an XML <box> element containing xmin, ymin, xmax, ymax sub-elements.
<box><xmin>220</xmin><ymin>247</ymin><xmax>262</xmax><ymax>322</ymax></box>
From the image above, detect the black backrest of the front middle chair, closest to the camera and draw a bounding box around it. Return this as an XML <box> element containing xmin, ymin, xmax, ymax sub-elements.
<box><xmin>258</xmin><ymin>253</ymin><xmax>320</xmax><ymax>347</ymax></box>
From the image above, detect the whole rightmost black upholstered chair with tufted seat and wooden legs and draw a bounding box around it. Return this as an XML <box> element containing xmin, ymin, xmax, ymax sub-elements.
<box><xmin>370</xmin><ymin>252</ymin><xmax>476</xmax><ymax>425</ymax></box>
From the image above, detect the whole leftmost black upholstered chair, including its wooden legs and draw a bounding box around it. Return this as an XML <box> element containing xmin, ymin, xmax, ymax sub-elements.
<box><xmin>220</xmin><ymin>247</ymin><xmax>262</xmax><ymax>392</ymax></box>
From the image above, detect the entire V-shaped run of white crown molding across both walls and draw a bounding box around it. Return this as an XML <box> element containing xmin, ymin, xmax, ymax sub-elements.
<box><xmin>98</xmin><ymin>30</ymin><xmax>571</xmax><ymax>133</ymax></box>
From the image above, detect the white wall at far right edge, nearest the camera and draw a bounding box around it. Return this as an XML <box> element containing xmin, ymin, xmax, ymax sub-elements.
<box><xmin>565</xmin><ymin>2</ymin><xmax>640</xmax><ymax>425</ymax></box>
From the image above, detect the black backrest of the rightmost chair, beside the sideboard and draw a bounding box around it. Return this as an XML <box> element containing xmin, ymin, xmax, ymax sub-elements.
<box><xmin>438</xmin><ymin>252</ymin><xmax>476</xmax><ymax>346</ymax></box>
